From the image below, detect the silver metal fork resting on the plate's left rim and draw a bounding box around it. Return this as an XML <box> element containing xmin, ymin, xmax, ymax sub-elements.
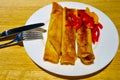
<box><xmin>0</xmin><ymin>31</ymin><xmax>43</xmax><ymax>48</ymax></box>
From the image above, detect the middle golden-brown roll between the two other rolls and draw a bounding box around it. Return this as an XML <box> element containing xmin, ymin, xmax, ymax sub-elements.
<box><xmin>60</xmin><ymin>8</ymin><xmax>76</xmax><ymax>65</ymax></box>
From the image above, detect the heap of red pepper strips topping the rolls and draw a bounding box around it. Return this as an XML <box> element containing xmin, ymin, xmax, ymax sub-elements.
<box><xmin>66</xmin><ymin>10</ymin><xmax>103</xmax><ymax>44</ymax></box>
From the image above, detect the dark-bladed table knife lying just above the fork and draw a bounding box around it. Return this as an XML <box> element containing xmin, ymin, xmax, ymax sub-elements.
<box><xmin>0</xmin><ymin>23</ymin><xmax>44</xmax><ymax>38</ymax></box>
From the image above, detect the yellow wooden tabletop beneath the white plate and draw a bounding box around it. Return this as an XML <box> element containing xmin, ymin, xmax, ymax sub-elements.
<box><xmin>0</xmin><ymin>0</ymin><xmax>120</xmax><ymax>80</ymax></box>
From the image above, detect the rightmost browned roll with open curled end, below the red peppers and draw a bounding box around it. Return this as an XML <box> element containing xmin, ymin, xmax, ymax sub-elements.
<box><xmin>76</xmin><ymin>18</ymin><xmax>95</xmax><ymax>64</ymax></box>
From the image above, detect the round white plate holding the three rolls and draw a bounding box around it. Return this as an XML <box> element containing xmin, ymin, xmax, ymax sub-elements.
<box><xmin>23</xmin><ymin>2</ymin><xmax>119</xmax><ymax>76</ymax></box>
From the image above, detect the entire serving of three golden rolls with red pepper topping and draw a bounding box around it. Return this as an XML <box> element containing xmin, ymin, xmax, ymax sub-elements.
<box><xmin>44</xmin><ymin>2</ymin><xmax>103</xmax><ymax>65</ymax></box>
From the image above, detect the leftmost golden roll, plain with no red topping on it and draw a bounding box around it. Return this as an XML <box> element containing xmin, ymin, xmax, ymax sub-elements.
<box><xmin>44</xmin><ymin>2</ymin><xmax>63</xmax><ymax>63</ymax></box>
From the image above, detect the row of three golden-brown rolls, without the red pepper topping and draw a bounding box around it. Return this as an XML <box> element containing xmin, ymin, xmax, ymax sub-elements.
<box><xmin>44</xmin><ymin>2</ymin><xmax>95</xmax><ymax>65</ymax></box>
